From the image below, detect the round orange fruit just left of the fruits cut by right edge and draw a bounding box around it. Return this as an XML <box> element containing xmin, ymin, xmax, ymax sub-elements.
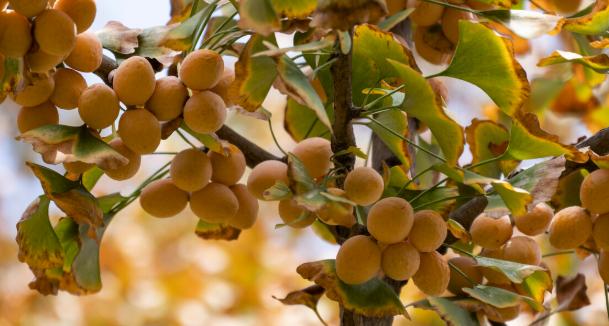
<box><xmin>549</xmin><ymin>206</ymin><xmax>592</xmax><ymax>249</ymax></box>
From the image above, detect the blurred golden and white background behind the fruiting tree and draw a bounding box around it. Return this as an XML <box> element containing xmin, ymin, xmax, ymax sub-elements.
<box><xmin>0</xmin><ymin>0</ymin><xmax>609</xmax><ymax>326</ymax></box>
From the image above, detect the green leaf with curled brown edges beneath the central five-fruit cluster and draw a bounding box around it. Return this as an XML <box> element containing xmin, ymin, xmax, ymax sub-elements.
<box><xmin>296</xmin><ymin>259</ymin><xmax>406</xmax><ymax>317</ymax></box>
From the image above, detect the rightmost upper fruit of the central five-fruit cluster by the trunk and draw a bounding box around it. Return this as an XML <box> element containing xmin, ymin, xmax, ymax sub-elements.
<box><xmin>408</xmin><ymin>210</ymin><xmax>448</xmax><ymax>252</ymax></box>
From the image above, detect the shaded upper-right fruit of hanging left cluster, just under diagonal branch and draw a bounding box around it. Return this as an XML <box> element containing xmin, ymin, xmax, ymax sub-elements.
<box><xmin>207</xmin><ymin>144</ymin><xmax>246</xmax><ymax>186</ymax></box>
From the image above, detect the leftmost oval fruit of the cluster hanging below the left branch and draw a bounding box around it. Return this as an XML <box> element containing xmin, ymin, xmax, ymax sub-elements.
<box><xmin>140</xmin><ymin>179</ymin><xmax>188</xmax><ymax>217</ymax></box>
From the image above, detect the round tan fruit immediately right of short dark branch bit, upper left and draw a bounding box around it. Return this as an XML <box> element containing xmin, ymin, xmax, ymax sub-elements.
<box><xmin>112</xmin><ymin>56</ymin><xmax>156</xmax><ymax>105</ymax></box>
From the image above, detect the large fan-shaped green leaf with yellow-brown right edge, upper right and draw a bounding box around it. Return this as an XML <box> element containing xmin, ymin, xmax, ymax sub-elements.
<box><xmin>437</xmin><ymin>20</ymin><xmax>531</xmax><ymax>115</ymax></box>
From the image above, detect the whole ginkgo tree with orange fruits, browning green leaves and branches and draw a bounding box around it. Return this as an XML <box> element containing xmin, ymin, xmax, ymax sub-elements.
<box><xmin>0</xmin><ymin>0</ymin><xmax>609</xmax><ymax>325</ymax></box>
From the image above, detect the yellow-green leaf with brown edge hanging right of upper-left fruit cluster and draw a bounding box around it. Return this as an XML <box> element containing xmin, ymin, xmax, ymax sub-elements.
<box><xmin>229</xmin><ymin>35</ymin><xmax>277</xmax><ymax>112</ymax></box>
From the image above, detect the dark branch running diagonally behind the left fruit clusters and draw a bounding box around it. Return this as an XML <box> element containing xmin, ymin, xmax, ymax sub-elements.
<box><xmin>94</xmin><ymin>55</ymin><xmax>281</xmax><ymax>167</ymax></box>
